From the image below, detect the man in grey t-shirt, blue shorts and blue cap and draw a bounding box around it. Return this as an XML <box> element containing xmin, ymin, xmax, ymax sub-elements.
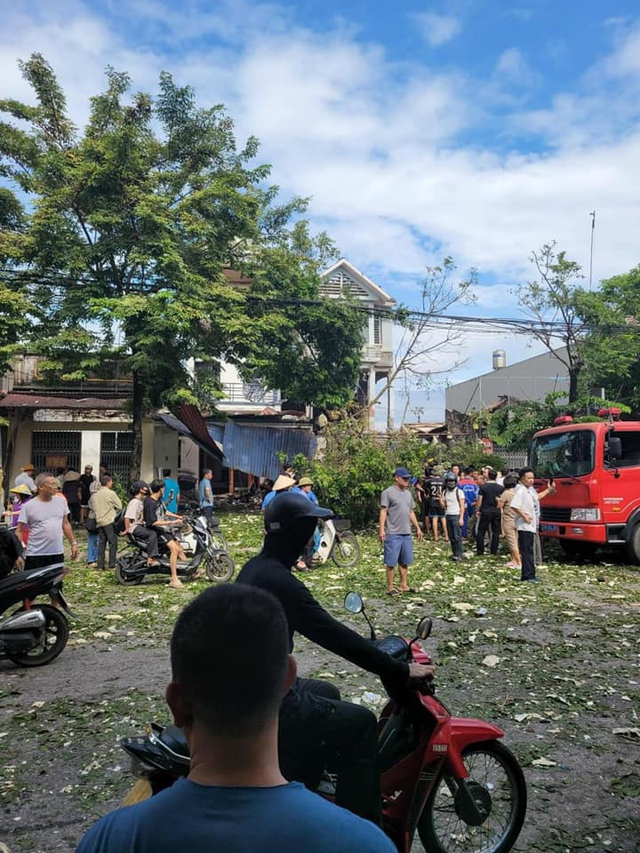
<box><xmin>378</xmin><ymin>468</ymin><xmax>422</xmax><ymax>596</ymax></box>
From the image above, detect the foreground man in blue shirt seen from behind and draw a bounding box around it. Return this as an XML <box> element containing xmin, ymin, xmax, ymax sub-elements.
<box><xmin>77</xmin><ymin>584</ymin><xmax>395</xmax><ymax>853</ymax></box>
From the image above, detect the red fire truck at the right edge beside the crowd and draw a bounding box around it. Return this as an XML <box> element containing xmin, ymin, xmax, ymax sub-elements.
<box><xmin>529</xmin><ymin>409</ymin><xmax>640</xmax><ymax>563</ymax></box>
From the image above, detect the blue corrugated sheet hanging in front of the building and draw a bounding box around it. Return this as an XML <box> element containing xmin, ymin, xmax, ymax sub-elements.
<box><xmin>224</xmin><ymin>421</ymin><xmax>317</xmax><ymax>480</ymax></box>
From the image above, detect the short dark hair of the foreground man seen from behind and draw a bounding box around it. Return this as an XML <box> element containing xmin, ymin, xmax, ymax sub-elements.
<box><xmin>171</xmin><ymin>584</ymin><xmax>289</xmax><ymax>737</ymax></box>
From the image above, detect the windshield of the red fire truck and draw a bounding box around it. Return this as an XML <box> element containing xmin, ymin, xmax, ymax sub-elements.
<box><xmin>529</xmin><ymin>429</ymin><xmax>596</xmax><ymax>478</ymax></box>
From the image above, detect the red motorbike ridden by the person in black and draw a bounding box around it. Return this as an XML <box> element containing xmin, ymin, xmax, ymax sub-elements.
<box><xmin>122</xmin><ymin>592</ymin><xmax>527</xmax><ymax>853</ymax></box>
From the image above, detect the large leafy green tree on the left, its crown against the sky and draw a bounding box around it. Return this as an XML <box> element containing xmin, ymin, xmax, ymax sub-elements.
<box><xmin>0</xmin><ymin>54</ymin><xmax>364</xmax><ymax>477</ymax></box>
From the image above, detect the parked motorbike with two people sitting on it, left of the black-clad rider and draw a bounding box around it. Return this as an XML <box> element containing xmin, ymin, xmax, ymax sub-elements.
<box><xmin>116</xmin><ymin>515</ymin><xmax>236</xmax><ymax>586</ymax></box>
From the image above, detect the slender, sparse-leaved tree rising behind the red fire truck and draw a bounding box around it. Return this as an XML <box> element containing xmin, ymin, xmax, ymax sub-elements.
<box><xmin>516</xmin><ymin>243</ymin><xmax>587</xmax><ymax>403</ymax></box>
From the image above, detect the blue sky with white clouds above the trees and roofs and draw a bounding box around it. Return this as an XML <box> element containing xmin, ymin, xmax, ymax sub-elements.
<box><xmin>0</xmin><ymin>0</ymin><xmax>640</xmax><ymax>420</ymax></box>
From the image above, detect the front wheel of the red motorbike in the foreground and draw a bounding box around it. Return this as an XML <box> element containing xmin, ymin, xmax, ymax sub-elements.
<box><xmin>418</xmin><ymin>740</ymin><xmax>527</xmax><ymax>853</ymax></box>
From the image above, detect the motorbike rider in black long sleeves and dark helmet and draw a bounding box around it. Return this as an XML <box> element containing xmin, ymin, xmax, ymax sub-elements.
<box><xmin>236</xmin><ymin>493</ymin><xmax>433</xmax><ymax>824</ymax></box>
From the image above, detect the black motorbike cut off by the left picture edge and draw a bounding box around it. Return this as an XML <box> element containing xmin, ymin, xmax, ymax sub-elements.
<box><xmin>0</xmin><ymin>563</ymin><xmax>73</xmax><ymax>666</ymax></box>
